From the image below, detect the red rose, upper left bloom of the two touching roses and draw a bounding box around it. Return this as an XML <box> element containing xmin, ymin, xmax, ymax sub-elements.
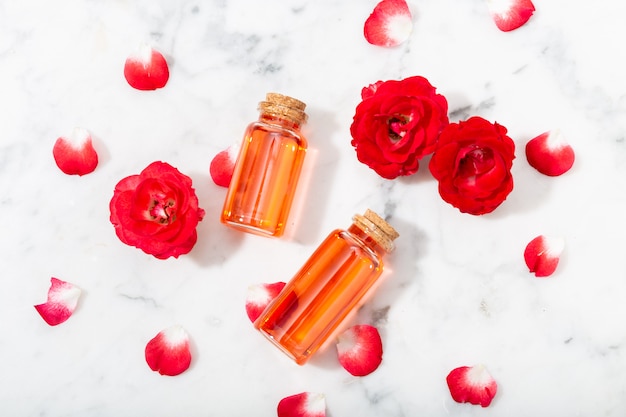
<box><xmin>350</xmin><ymin>77</ymin><xmax>448</xmax><ymax>179</ymax></box>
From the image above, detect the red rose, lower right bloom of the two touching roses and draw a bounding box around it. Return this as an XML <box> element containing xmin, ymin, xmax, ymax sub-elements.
<box><xmin>429</xmin><ymin>117</ymin><xmax>515</xmax><ymax>215</ymax></box>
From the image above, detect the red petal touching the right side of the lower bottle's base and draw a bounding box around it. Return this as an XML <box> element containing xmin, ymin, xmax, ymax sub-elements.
<box><xmin>337</xmin><ymin>324</ymin><xmax>383</xmax><ymax>376</ymax></box>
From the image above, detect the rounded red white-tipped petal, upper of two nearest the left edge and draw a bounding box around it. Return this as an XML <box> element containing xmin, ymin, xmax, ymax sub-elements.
<box><xmin>52</xmin><ymin>128</ymin><xmax>98</xmax><ymax>175</ymax></box>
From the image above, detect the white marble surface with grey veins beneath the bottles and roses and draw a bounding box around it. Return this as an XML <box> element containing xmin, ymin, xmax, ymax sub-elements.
<box><xmin>0</xmin><ymin>0</ymin><xmax>626</xmax><ymax>417</ymax></box>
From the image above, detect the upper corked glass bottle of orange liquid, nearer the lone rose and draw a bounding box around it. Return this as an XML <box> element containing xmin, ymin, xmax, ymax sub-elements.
<box><xmin>221</xmin><ymin>93</ymin><xmax>307</xmax><ymax>237</ymax></box>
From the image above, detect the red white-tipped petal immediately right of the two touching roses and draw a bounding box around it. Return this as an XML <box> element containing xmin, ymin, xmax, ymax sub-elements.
<box><xmin>526</xmin><ymin>131</ymin><xmax>575</xmax><ymax>177</ymax></box>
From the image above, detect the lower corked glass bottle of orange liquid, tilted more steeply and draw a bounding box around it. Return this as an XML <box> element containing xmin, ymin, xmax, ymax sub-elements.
<box><xmin>254</xmin><ymin>210</ymin><xmax>399</xmax><ymax>365</ymax></box>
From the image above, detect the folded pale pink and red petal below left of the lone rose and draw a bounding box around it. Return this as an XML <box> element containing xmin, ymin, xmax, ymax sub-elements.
<box><xmin>35</xmin><ymin>277</ymin><xmax>81</xmax><ymax>326</ymax></box>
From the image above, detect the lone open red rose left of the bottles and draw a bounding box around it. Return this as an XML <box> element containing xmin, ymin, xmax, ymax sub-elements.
<box><xmin>109</xmin><ymin>162</ymin><xmax>204</xmax><ymax>259</ymax></box>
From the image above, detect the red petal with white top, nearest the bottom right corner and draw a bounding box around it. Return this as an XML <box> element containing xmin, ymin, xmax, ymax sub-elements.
<box><xmin>446</xmin><ymin>365</ymin><xmax>498</xmax><ymax>407</ymax></box>
